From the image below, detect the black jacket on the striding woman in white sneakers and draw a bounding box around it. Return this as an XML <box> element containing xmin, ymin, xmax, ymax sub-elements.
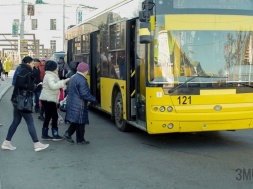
<box><xmin>11</xmin><ymin>63</ymin><xmax>36</xmax><ymax>103</ymax></box>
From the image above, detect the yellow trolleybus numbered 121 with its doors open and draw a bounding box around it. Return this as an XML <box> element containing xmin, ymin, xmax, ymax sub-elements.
<box><xmin>65</xmin><ymin>0</ymin><xmax>253</xmax><ymax>134</ymax></box>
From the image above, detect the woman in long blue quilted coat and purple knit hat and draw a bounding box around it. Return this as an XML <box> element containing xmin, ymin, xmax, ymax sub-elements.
<box><xmin>64</xmin><ymin>62</ymin><xmax>97</xmax><ymax>144</ymax></box>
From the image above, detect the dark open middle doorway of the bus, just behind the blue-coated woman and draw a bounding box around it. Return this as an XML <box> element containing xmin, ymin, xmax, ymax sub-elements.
<box><xmin>90</xmin><ymin>31</ymin><xmax>100</xmax><ymax>103</ymax></box>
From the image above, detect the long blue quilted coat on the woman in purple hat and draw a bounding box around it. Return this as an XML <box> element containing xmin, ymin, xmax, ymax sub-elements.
<box><xmin>65</xmin><ymin>72</ymin><xmax>96</xmax><ymax>125</ymax></box>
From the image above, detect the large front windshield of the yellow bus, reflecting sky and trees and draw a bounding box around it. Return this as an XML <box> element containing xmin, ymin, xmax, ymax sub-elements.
<box><xmin>153</xmin><ymin>30</ymin><xmax>253</xmax><ymax>83</ymax></box>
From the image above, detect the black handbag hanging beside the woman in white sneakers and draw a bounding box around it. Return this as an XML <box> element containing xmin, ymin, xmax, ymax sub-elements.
<box><xmin>17</xmin><ymin>90</ymin><xmax>33</xmax><ymax>113</ymax></box>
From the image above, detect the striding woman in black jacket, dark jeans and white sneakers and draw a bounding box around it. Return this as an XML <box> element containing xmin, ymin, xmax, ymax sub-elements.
<box><xmin>1</xmin><ymin>56</ymin><xmax>49</xmax><ymax>151</ymax></box>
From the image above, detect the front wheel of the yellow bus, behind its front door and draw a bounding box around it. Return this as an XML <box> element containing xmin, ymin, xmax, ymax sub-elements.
<box><xmin>114</xmin><ymin>92</ymin><xmax>127</xmax><ymax>131</ymax></box>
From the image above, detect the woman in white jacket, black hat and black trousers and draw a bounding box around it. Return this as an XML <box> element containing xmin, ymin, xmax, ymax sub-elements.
<box><xmin>40</xmin><ymin>60</ymin><xmax>69</xmax><ymax>141</ymax></box>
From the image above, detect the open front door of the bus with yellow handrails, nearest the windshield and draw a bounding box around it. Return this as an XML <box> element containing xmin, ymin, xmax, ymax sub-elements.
<box><xmin>126</xmin><ymin>19</ymin><xmax>146</xmax><ymax>130</ymax></box>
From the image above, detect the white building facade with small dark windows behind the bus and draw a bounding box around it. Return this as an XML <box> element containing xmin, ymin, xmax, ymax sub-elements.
<box><xmin>0</xmin><ymin>2</ymin><xmax>92</xmax><ymax>62</ymax></box>
